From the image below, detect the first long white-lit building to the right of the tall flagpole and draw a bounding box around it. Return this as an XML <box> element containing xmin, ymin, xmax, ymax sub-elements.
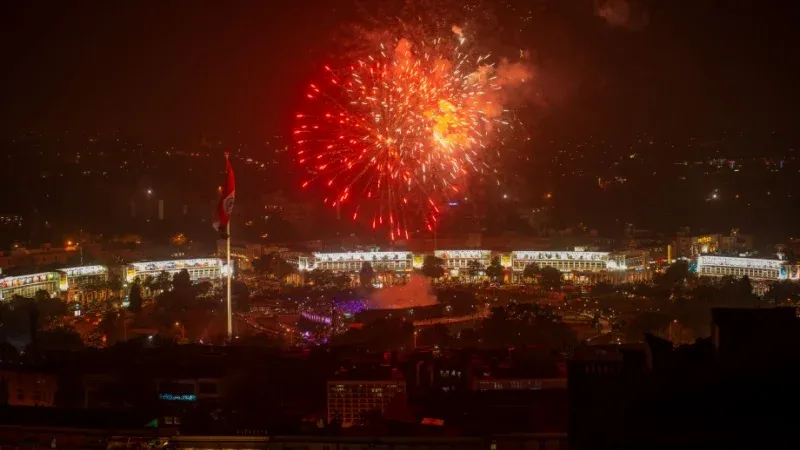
<box><xmin>310</xmin><ymin>252</ymin><xmax>414</xmax><ymax>273</ymax></box>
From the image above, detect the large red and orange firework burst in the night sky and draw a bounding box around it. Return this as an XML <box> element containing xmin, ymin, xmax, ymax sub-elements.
<box><xmin>294</xmin><ymin>26</ymin><xmax>530</xmax><ymax>240</ymax></box>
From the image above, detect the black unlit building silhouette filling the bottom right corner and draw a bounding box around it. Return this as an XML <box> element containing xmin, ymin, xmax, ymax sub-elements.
<box><xmin>568</xmin><ymin>308</ymin><xmax>800</xmax><ymax>450</ymax></box>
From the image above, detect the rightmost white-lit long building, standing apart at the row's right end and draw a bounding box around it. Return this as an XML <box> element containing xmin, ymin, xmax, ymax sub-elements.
<box><xmin>697</xmin><ymin>255</ymin><xmax>790</xmax><ymax>280</ymax></box>
